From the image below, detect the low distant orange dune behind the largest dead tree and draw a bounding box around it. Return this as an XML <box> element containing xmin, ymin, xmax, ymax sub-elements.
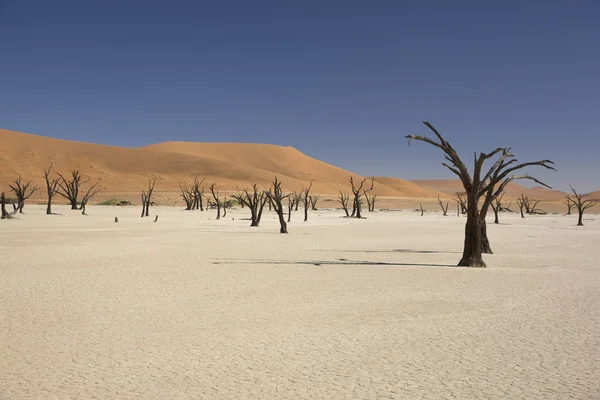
<box><xmin>412</xmin><ymin>179</ymin><xmax>565</xmax><ymax>201</ymax></box>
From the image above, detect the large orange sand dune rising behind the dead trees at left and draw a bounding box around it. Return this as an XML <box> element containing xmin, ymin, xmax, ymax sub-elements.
<box><xmin>0</xmin><ymin>129</ymin><xmax>437</xmax><ymax>197</ymax></box>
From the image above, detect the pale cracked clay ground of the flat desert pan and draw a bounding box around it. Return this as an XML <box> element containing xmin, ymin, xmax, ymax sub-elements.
<box><xmin>0</xmin><ymin>205</ymin><xmax>600</xmax><ymax>400</ymax></box>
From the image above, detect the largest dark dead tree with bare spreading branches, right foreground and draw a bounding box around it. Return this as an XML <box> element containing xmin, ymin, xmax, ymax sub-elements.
<box><xmin>406</xmin><ymin>122</ymin><xmax>554</xmax><ymax>267</ymax></box>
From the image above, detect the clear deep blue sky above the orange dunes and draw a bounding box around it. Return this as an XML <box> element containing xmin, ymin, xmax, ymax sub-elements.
<box><xmin>0</xmin><ymin>0</ymin><xmax>600</xmax><ymax>191</ymax></box>
